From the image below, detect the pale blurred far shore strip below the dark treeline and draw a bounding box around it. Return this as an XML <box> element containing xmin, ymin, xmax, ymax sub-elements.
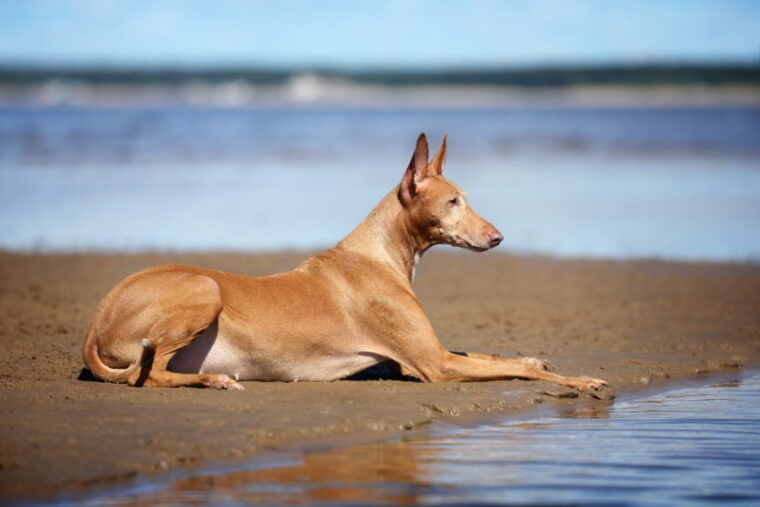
<box><xmin>0</xmin><ymin>83</ymin><xmax>760</xmax><ymax>110</ymax></box>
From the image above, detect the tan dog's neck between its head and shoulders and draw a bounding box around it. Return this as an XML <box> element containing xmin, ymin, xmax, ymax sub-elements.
<box><xmin>337</xmin><ymin>187</ymin><xmax>433</xmax><ymax>283</ymax></box>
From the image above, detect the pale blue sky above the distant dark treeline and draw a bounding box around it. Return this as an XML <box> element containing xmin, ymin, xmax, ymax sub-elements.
<box><xmin>0</xmin><ymin>0</ymin><xmax>760</xmax><ymax>67</ymax></box>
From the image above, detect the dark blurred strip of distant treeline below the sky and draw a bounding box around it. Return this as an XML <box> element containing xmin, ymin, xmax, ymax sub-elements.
<box><xmin>0</xmin><ymin>60</ymin><xmax>760</xmax><ymax>88</ymax></box>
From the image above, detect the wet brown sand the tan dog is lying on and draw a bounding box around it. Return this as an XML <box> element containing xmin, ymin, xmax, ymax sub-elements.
<box><xmin>0</xmin><ymin>249</ymin><xmax>760</xmax><ymax>500</ymax></box>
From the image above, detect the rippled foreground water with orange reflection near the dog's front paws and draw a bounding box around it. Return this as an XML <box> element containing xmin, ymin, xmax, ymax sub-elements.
<box><xmin>53</xmin><ymin>374</ymin><xmax>760</xmax><ymax>506</ymax></box>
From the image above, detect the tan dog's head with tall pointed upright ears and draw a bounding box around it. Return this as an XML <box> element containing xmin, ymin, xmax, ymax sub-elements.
<box><xmin>398</xmin><ymin>134</ymin><xmax>504</xmax><ymax>252</ymax></box>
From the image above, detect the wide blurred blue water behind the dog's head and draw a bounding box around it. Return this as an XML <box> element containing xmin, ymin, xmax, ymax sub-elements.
<box><xmin>0</xmin><ymin>107</ymin><xmax>760</xmax><ymax>260</ymax></box>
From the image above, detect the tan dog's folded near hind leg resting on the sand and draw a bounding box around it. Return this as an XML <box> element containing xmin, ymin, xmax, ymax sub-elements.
<box><xmin>128</xmin><ymin>275</ymin><xmax>243</xmax><ymax>390</ymax></box>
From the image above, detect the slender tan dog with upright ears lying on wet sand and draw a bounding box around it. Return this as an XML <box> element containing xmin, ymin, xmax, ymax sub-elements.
<box><xmin>83</xmin><ymin>134</ymin><xmax>605</xmax><ymax>390</ymax></box>
